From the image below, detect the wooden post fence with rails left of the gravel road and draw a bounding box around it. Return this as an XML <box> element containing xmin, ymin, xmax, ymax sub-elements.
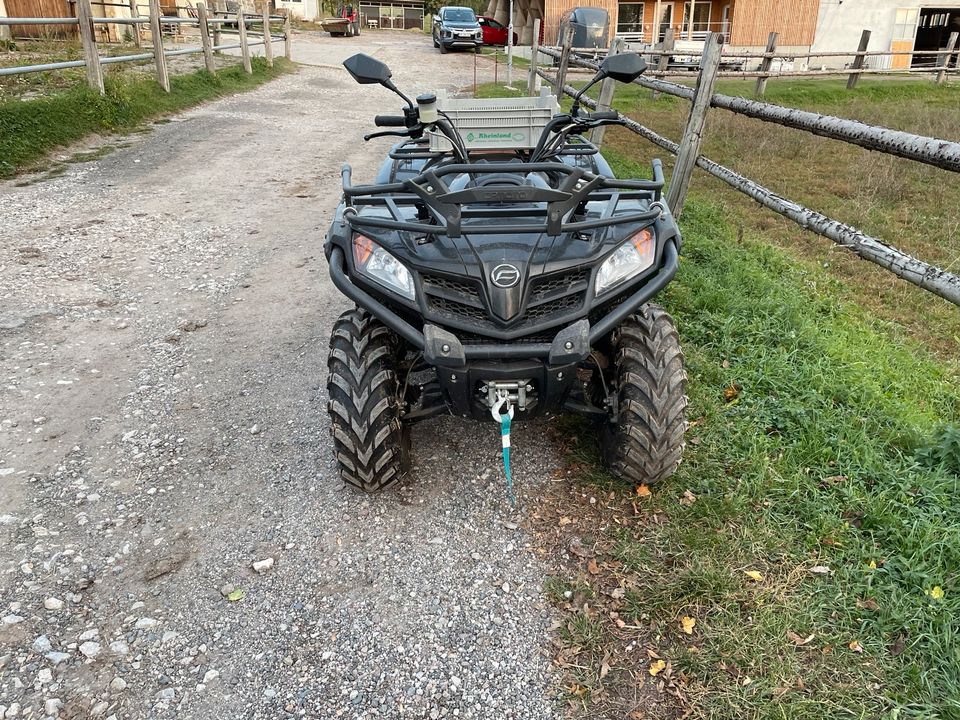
<box><xmin>0</xmin><ymin>0</ymin><xmax>291</xmax><ymax>95</ymax></box>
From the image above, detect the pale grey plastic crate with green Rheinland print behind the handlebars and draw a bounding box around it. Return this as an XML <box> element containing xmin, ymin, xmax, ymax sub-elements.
<box><xmin>428</xmin><ymin>87</ymin><xmax>560</xmax><ymax>152</ymax></box>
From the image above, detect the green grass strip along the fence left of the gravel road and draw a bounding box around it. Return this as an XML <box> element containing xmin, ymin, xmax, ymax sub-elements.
<box><xmin>0</xmin><ymin>58</ymin><xmax>292</xmax><ymax>178</ymax></box>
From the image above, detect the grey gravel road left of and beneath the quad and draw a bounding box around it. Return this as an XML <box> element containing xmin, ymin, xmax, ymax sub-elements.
<box><xmin>0</xmin><ymin>32</ymin><xmax>559</xmax><ymax>720</ymax></box>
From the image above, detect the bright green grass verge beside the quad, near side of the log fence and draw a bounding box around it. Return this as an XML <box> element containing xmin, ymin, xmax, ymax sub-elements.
<box><xmin>552</xmin><ymin>194</ymin><xmax>960</xmax><ymax>720</ymax></box>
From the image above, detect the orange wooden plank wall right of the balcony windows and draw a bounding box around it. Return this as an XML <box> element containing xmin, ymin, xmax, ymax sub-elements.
<box><xmin>730</xmin><ymin>0</ymin><xmax>820</xmax><ymax>46</ymax></box>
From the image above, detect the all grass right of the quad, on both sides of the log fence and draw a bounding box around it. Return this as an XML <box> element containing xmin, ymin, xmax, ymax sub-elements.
<box><xmin>470</xmin><ymin>81</ymin><xmax>960</xmax><ymax>720</ymax></box>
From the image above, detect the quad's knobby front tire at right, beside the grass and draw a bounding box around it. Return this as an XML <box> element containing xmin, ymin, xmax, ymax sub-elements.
<box><xmin>600</xmin><ymin>303</ymin><xmax>687</xmax><ymax>485</ymax></box>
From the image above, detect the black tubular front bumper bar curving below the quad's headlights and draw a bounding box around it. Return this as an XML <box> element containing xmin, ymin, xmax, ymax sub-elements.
<box><xmin>329</xmin><ymin>241</ymin><xmax>679</xmax><ymax>362</ymax></box>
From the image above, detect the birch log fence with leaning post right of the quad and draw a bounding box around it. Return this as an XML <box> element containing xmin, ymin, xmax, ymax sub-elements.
<box><xmin>528</xmin><ymin>33</ymin><xmax>960</xmax><ymax>306</ymax></box>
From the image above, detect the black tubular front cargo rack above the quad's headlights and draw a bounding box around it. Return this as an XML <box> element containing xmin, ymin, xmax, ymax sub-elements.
<box><xmin>341</xmin><ymin>160</ymin><xmax>666</xmax><ymax>238</ymax></box>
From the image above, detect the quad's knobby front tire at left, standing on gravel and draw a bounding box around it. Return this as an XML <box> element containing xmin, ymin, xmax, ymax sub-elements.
<box><xmin>327</xmin><ymin>309</ymin><xmax>410</xmax><ymax>493</ymax></box>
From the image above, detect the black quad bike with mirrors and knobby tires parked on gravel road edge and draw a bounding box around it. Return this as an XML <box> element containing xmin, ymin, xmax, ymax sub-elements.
<box><xmin>324</xmin><ymin>49</ymin><xmax>687</xmax><ymax>492</ymax></box>
